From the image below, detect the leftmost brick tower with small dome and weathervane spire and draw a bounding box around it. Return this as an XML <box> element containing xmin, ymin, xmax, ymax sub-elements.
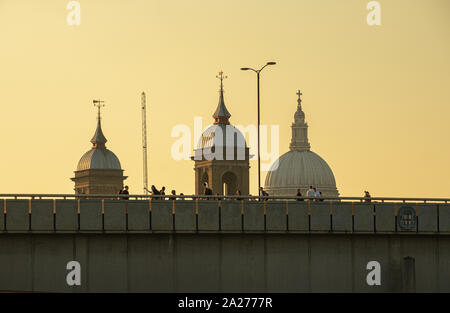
<box><xmin>71</xmin><ymin>100</ymin><xmax>127</xmax><ymax>194</ymax></box>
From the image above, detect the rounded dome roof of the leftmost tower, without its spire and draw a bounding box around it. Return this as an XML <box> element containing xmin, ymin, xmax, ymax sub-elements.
<box><xmin>77</xmin><ymin>148</ymin><xmax>121</xmax><ymax>171</ymax></box>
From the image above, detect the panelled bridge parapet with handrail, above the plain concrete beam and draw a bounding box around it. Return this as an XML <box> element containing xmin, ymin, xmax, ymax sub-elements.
<box><xmin>0</xmin><ymin>194</ymin><xmax>450</xmax><ymax>234</ymax></box>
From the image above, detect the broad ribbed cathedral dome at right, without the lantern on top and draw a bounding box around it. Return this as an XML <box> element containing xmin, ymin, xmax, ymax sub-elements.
<box><xmin>265</xmin><ymin>150</ymin><xmax>339</xmax><ymax>197</ymax></box>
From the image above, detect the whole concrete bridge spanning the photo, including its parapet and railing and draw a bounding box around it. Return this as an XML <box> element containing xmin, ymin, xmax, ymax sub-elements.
<box><xmin>0</xmin><ymin>194</ymin><xmax>450</xmax><ymax>292</ymax></box>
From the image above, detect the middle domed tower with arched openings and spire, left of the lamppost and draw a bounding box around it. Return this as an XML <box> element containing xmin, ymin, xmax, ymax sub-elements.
<box><xmin>192</xmin><ymin>72</ymin><xmax>250</xmax><ymax>195</ymax></box>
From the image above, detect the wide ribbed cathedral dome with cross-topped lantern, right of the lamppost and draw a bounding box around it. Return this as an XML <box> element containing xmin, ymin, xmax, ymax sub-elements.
<box><xmin>265</xmin><ymin>91</ymin><xmax>339</xmax><ymax>197</ymax></box>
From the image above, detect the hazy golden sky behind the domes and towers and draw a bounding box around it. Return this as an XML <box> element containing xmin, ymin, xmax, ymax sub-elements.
<box><xmin>0</xmin><ymin>0</ymin><xmax>450</xmax><ymax>197</ymax></box>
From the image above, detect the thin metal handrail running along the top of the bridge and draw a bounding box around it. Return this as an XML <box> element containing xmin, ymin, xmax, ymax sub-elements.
<box><xmin>0</xmin><ymin>194</ymin><xmax>450</xmax><ymax>203</ymax></box>
